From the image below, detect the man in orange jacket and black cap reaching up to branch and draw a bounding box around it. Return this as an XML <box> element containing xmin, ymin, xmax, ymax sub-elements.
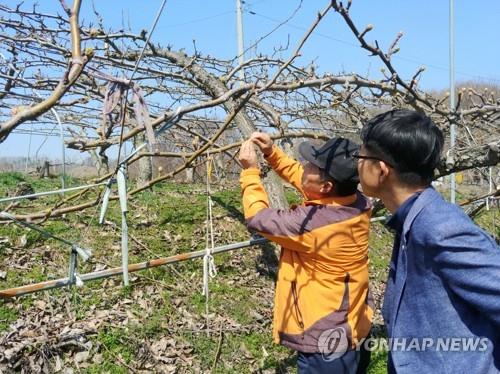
<box><xmin>239</xmin><ymin>132</ymin><xmax>373</xmax><ymax>373</ymax></box>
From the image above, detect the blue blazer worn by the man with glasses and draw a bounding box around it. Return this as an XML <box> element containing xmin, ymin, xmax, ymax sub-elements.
<box><xmin>382</xmin><ymin>187</ymin><xmax>500</xmax><ymax>374</ymax></box>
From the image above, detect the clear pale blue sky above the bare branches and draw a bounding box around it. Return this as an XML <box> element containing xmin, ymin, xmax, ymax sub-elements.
<box><xmin>0</xmin><ymin>0</ymin><xmax>500</xmax><ymax>158</ymax></box>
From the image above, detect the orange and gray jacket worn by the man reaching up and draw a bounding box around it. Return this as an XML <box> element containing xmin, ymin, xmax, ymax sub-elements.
<box><xmin>240</xmin><ymin>146</ymin><xmax>373</xmax><ymax>353</ymax></box>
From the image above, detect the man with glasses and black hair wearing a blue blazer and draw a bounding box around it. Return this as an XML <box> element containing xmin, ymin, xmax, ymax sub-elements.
<box><xmin>354</xmin><ymin>110</ymin><xmax>500</xmax><ymax>373</ymax></box>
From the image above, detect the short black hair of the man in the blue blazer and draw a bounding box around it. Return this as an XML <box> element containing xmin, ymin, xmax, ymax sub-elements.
<box><xmin>361</xmin><ymin>109</ymin><xmax>444</xmax><ymax>186</ymax></box>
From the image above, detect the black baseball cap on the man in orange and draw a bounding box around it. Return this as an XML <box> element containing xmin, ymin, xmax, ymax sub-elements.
<box><xmin>299</xmin><ymin>138</ymin><xmax>359</xmax><ymax>183</ymax></box>
